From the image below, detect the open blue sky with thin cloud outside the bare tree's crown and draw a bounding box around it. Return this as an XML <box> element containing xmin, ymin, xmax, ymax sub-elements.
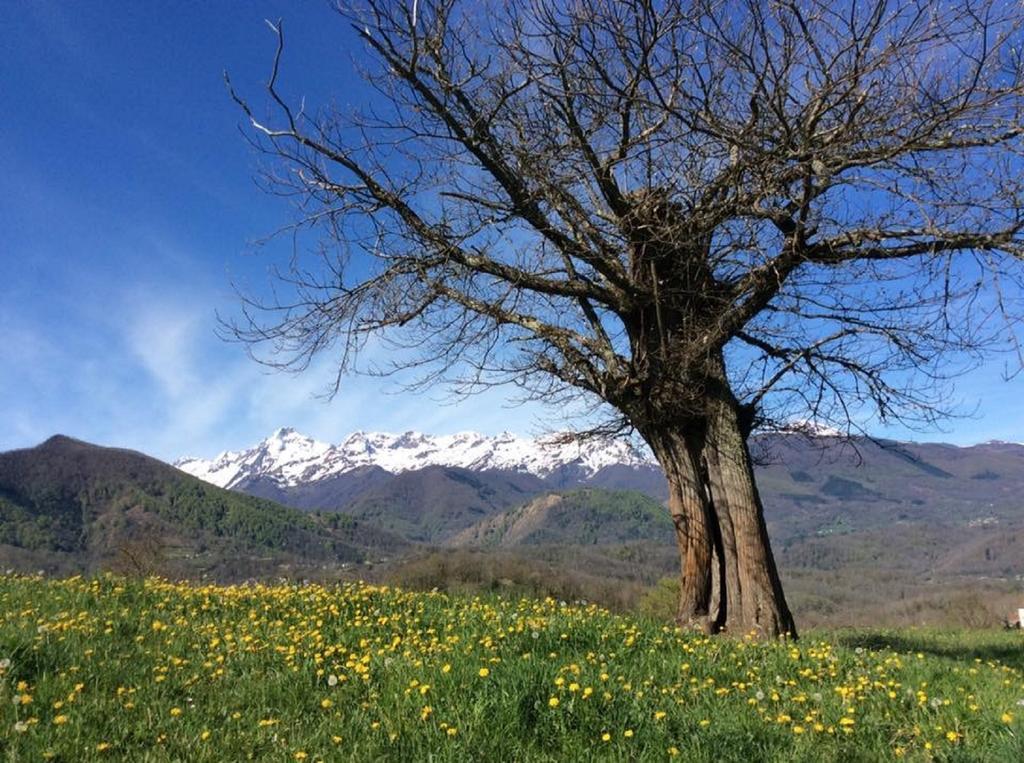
<box><xmin>0</xmin><ymin>0</ymin><xmax>1024</xmax><ymax>459</ymax></box>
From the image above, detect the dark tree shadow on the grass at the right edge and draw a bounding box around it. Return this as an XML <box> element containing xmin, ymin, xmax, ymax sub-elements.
<box><xmin>835</xmin><ymin>631</ymin><xmax>1024</xmax><ymax>671</ymax></box>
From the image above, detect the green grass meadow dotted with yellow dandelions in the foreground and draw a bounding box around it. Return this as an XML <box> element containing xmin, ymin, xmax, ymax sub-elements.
<box><xmin>0</xmin><ymin>576</ymin><xmax>1024</xmax><ymax>763</ymax></box>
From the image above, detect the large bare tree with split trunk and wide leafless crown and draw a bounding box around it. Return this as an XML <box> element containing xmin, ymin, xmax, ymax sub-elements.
<box><xmin>231</xmin><ymin>0</ymin><xmax>1024</xmax><ymax>635</ymax></box>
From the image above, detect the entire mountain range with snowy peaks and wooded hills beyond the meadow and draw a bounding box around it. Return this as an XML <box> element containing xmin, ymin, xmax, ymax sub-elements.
<box><xmin>0</xmin><ymin>429</ymin><xmax>1024</xmax><ymax>622</ymax></box>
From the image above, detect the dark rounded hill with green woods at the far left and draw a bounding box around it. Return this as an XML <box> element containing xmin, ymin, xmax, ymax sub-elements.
<box><xmin>0</xmin><ymin>435</ymin><xmax>399</xmax><ymax>577</ymax></box>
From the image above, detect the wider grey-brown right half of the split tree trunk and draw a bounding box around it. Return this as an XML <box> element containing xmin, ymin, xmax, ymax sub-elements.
<box><xmin>703</xmin><ymin>380</ymin><xmax>797</xmax><ymax>638</ymax></box>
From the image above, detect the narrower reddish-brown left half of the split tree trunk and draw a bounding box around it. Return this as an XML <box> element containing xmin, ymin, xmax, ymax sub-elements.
<box><xmin>645</xmin><ymin>428</ymin><xmax>721</xmax><ymax>633</ymax></box>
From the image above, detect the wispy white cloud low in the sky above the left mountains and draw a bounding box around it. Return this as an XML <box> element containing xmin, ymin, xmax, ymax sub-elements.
<box><xmin>0</xmin><ymin>262</ymin><xmax>565</xmax><ymax>460</ymax></box>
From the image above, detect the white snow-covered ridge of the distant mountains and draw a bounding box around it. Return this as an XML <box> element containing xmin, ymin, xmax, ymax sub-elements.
<box><xmin>174</xmin><ymin>428</ymin><xmax>654</xmax><ymax>488</ymax></box>
